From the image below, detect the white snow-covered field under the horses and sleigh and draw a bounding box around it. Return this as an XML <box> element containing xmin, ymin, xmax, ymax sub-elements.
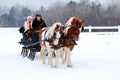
<box><xmin>0</xmin><ymin>28</ymin><xmax>120</xmax><ymax>80</ymax></box>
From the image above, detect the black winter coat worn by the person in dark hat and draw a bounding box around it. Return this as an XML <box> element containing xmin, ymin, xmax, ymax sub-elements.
<box><xmin>32</xmin><ymin>19</ymin><xmax>47</xmax><ymax>29</ymax></box>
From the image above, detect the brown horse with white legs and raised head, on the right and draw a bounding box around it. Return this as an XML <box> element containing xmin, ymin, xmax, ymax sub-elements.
<box><xmin>61</xmin><ymin>17</ymin><xmax>84</xmax><ymax>67</ymax></box>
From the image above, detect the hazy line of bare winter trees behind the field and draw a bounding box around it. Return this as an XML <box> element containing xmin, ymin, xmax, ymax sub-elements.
<box><xmin>0</xmin><ymin>0</ymin><xmax>120</xmax><ymax>27</ymax></box>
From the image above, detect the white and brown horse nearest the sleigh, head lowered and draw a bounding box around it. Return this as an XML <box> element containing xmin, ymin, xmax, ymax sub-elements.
<box><xmin>39</xmin><ymin>23</ymin><xmax>62</xmax><ymax>67</ymax></box>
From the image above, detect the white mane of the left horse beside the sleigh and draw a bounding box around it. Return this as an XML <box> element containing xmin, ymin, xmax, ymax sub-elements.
<box><xmin>46</xmin><ymin>22</ymin><xmax>62</xmax><ymax>38</ymax></box>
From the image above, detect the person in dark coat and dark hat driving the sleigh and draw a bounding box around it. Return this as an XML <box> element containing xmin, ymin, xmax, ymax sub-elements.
<box><xmin>32</xmin><ymin>14</ymin><xmax>47</xmax><ymax>29</ymax></box>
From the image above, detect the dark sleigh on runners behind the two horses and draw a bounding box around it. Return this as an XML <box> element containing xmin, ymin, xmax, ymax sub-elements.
<box><xmin>19</xmin><ymin>27</ymin><xmax>41</xmax><ymax>61</ymax></box>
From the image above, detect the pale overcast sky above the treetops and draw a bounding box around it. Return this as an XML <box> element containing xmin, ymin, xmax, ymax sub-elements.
<box><xmin>0</xmin><ymin>0</ymin><xmax>114</xmax><ymax>9</ymax></box>
